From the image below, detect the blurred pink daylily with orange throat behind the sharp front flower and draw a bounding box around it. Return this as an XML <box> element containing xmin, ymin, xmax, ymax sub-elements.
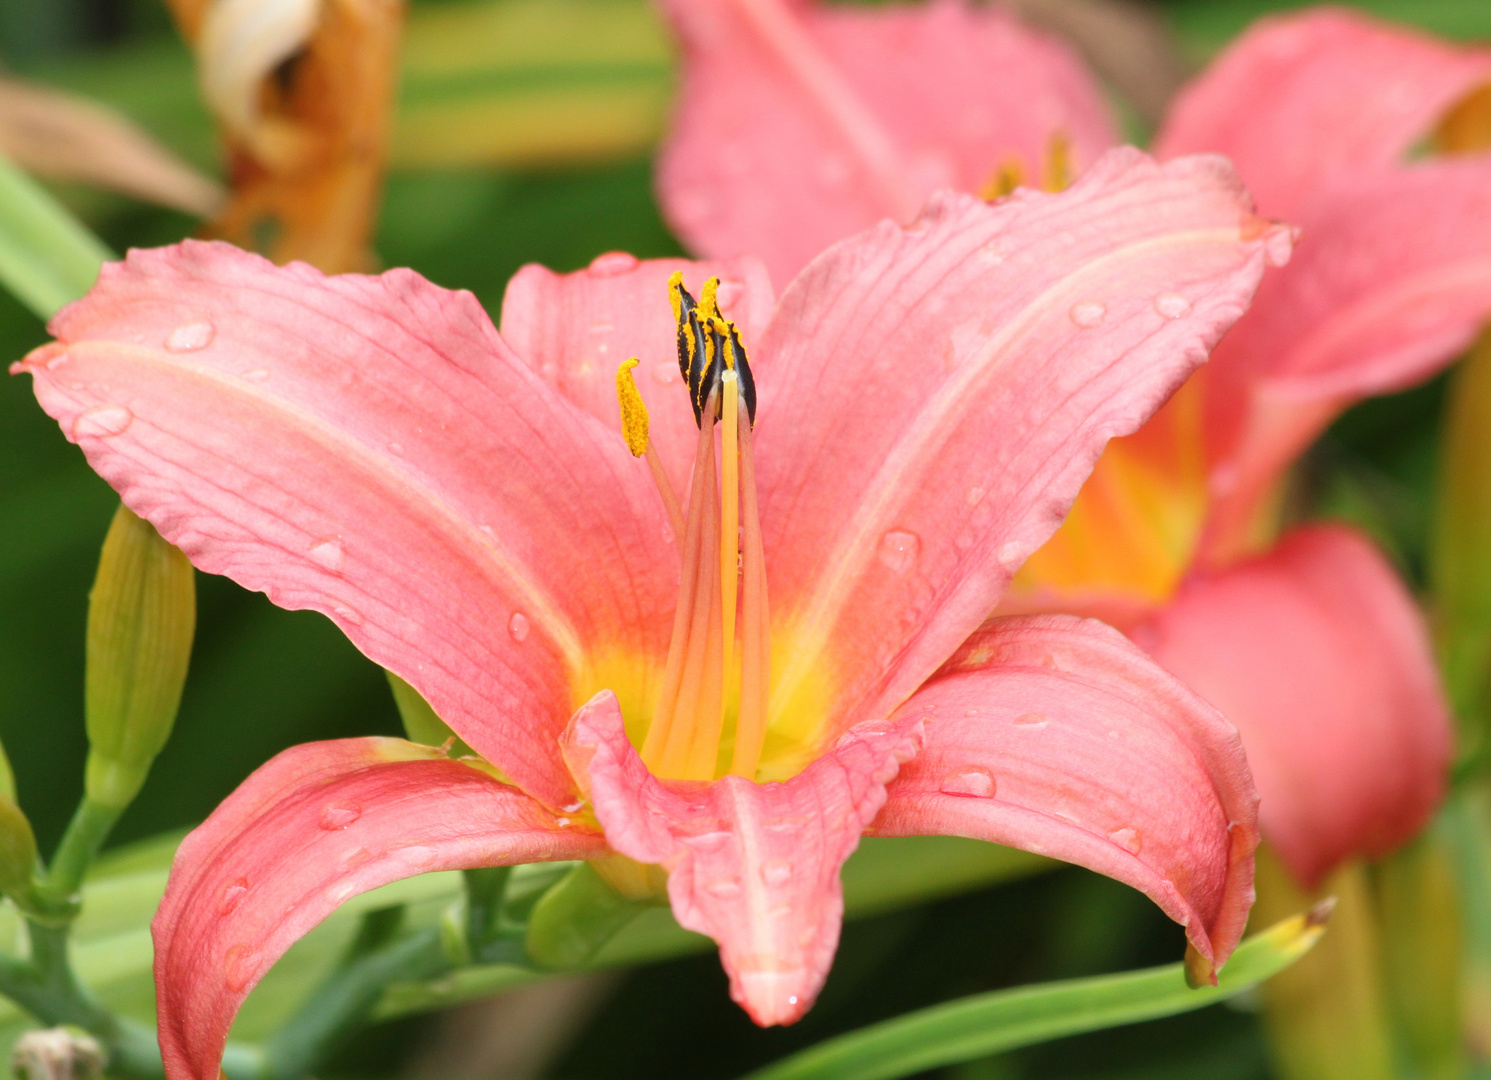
<box><xmin>659</xmin><ymin>0</ymin><xmax>1491</xmax><ymax>885</ymax></box>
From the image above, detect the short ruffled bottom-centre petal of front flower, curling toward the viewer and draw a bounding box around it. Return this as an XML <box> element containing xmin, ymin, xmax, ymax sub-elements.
<box><xmin>567</xmin><ymin>692</ymin><xmax>920</xmax><ymax>1026</ymax></box>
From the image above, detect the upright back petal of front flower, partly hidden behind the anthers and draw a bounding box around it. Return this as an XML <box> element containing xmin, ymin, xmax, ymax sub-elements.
<box><xmin>502</xmin><ymin>252</ymin><xmax>772</xmax><ymax>492</ymax></box>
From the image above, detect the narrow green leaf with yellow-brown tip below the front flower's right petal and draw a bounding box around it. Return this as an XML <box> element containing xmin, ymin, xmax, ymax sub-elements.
<box><xmin>744</xmin><ymin>908</ymin><xmax>1328</xmax><ymax>1080</ymax></box>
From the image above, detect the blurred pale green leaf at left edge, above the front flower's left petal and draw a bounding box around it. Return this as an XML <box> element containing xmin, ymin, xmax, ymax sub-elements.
<box><xmin>0</xmin><ymin>158</ymin><xmax>113</xmax><ymax>319</ymax></box>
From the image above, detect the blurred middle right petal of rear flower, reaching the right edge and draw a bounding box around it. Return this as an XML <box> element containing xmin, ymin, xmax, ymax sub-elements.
<box><xmin>1205</xmin><ymin>157</ymin><xmax>1491</xmax><ymax>562</ymax></box>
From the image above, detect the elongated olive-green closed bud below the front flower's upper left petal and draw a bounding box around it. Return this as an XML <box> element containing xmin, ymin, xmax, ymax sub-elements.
<box><xmin>83</xmin><ymin>506</ymin><xmax>197</xmax><ymax>810</ymax></box>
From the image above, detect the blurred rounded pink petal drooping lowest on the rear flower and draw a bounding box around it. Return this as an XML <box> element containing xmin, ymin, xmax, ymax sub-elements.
<box><xmin>1135</xmin><ymin>525</ymin><xmax>1451</xmax><ymax>888</ymax></box>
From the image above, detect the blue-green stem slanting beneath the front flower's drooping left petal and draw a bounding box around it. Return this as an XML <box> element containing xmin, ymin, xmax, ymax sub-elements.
<box><xmin>262</xmin><ymin>929</ymin><xmax>450</xmax><ymax>1080</ymax></box>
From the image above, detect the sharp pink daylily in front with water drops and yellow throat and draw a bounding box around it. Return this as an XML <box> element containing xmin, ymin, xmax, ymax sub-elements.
<box><xmin>13</xmin><ymin>151</ymin><xmax>1290</xmax><ymax>1080</ymax></box>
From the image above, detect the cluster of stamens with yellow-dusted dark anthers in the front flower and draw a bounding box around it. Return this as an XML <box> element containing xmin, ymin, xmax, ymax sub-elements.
<box><xmin>616</xmin><ymin>273</ymin><xmax>771</xmax><ymax>780</ymax></box>
